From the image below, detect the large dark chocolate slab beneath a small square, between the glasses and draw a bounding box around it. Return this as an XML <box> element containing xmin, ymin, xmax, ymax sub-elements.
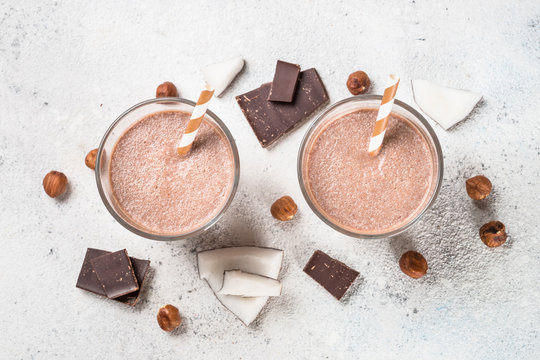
<box><xmin>236</xmin><ymin>69</ymin><xmax>328</xmax><ymax>147</ymax></box>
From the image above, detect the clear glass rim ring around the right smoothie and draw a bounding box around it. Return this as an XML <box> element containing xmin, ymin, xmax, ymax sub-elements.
<box><xmin>297</xmin><ymin>95</ymin><xmax>444</xmax><ymax>239</ymax></box>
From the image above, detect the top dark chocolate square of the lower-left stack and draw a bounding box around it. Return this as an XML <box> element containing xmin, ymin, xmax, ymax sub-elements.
<box><xmin>90</xmin><ymin>249</ymin><xmax>139</xmax><ymax>299</ymax></box>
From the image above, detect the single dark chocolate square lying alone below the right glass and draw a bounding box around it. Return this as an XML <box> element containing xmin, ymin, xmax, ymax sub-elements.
<box><xmin>304</xmin><ymin>250</ymin><xmax>360</xmax><ymax>300</ymax></box>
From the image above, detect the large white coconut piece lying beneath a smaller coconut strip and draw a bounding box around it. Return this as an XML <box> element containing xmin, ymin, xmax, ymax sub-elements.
<box><xmin>197</xmin><ymin>246</ymin><xmax>283</xmax><ymax>326</ymax></box>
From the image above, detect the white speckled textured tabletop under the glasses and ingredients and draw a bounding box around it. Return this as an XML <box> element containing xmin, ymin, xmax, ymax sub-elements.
<box><xmin>0</xmin><ymin>0</ymin><xmax>540</xmax><ymax>359</ymax></box>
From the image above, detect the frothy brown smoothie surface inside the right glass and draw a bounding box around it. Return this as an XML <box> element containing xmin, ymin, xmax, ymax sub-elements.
<box><xmin>306</xmin><ymin>109</ymin><xmax>435</xmax><ymax>233</ymax></box>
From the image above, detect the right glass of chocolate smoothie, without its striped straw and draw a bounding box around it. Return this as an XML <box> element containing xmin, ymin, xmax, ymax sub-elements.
<box><xmin>298</xmin><ymin>95</ymin><xmax>443</xmax><ymax>239</ymax></box>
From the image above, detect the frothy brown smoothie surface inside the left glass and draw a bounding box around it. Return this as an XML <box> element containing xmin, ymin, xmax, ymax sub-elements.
<box><xmin>110</xmin><ymin>111</ymin><xmax>234</xmax><ymax>234</ymax></box>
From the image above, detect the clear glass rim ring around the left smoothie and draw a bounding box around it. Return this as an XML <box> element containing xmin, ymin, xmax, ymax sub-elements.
<box><xmin>95</xmin><ymin>97</ymin><xmax>240</xmax><ymax>241</ymax></box>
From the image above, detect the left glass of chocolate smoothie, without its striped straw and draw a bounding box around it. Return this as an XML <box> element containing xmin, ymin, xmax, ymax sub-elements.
<box><xmin>96</xmin><ymin>98</ymin><xmax>240</xmax><ymax>240</ymax></box>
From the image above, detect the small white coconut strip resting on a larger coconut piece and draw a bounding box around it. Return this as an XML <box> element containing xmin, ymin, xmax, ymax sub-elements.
<box><xmin>216</xmin><ymin>270</ymin><xmax>281</xmax><ymax>297</ymax></box>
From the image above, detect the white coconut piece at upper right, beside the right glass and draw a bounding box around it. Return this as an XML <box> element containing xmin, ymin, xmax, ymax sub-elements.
<box><xmin>412</xmin><ymin>80</ymin><xmax>482</xmax><ymax>130</ymax></box>
